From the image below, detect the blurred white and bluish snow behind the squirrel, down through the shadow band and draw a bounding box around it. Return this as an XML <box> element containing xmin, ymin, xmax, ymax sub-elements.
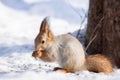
<box><xmin>0</xmin><ymin>0</ymin><xmax>89</xmax><ymax>55</ymax></box>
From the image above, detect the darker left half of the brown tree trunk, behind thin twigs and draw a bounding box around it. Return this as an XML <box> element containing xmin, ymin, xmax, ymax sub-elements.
<box><xmin>86</xmin><ymin>0</ymin><xmax>103</xmax><ymax>54</ymax></box>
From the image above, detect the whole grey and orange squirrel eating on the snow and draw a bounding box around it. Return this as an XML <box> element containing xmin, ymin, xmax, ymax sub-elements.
<box><xmin>32</xmin><ymin>17</ymin><xmax>113</xmax><ymax>74</ymax></box>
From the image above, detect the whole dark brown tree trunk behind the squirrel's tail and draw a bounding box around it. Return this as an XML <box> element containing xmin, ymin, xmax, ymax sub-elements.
<box><xmin>86</xmin><ymin>0</ymin><xmax>120</xmax><ymax>68</ymax></box>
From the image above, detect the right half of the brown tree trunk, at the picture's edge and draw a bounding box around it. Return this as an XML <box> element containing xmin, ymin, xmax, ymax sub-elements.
<box><xmin>103</xmin><ymin>0</ymin><xmax>120</xmax><ymax>68</ymax></box>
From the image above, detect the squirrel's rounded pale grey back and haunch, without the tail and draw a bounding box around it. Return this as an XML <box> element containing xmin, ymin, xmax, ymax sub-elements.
<box><xmin>55</xmin><ymin>34</ymin><xmax>85</xmax><ymax>71</ymax></box>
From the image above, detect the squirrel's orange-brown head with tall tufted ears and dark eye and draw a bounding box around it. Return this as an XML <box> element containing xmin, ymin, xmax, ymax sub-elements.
<box><xmin>35</xmin><ymin>17</ymin><xmax>54</xmax><ymax>51</ymax></box>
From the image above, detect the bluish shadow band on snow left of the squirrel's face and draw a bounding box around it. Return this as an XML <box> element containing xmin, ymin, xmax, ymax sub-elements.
<box><xmin>0</xmin><ymin>44</ymin><xmax>34</xmax><ymax>56</ymax></box>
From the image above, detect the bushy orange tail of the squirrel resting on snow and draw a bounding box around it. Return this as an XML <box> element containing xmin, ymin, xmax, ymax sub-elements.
<box><xmin>86</xmin><ymin>54</ymin><xmax>113</xmax><ymax>73</ymax></box>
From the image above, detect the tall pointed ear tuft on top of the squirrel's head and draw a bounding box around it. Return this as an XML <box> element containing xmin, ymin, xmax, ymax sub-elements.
<box><xmin>40</xmin><ymin>17</ymin><xmax>49</xmax><ymax>34</ymax></box>
